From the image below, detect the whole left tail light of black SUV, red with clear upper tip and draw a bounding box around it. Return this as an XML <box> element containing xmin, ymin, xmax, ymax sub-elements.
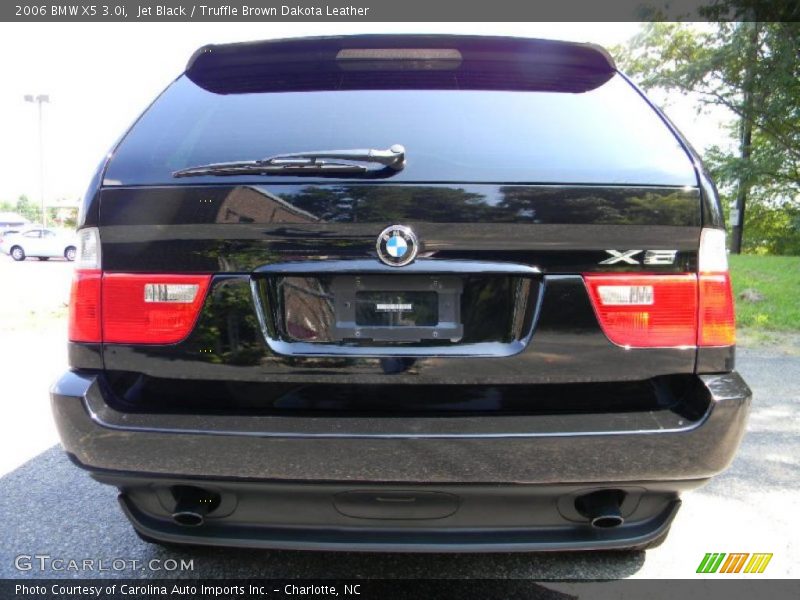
<box><xmin>69</xmin><ymin>228</ymin><xmax>211</xmax><ymax>344</ymax></box>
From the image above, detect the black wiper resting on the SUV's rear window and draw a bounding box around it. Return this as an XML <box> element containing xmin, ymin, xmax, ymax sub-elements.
<box><xmin>172</xmin><ymin>144</ymin><xmax>406</xmax><ymax>177</ymax></box>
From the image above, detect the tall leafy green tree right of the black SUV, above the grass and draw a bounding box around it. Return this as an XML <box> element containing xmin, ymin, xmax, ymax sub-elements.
<box><xmin>616</xmin><ymin>16</ymin><xmax>800</xmax><ymax>252</ymax></box>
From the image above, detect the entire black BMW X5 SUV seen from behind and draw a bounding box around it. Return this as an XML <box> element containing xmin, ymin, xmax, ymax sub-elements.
<box><xmin>52</xmin><ymin>36</ymin><xmax>751</xmax><ymax>551</ymax></box>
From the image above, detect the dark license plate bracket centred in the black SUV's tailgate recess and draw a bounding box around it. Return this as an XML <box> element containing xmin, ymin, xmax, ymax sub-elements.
<box><xmin>331</xmin><ymin>275</ymin><xmax>464</xmax><ymax>343</ymax></box>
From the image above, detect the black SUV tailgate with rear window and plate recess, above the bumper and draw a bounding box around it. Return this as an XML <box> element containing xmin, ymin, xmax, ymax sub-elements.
<box><xmin>79</xmin><ymin>37</ymin><xmax>703</xmax><ymax>408</ymax></box>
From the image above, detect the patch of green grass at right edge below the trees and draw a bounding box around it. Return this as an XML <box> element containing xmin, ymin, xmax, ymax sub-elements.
<box><xmin>729</xmin><ymin>255</ymin><xmax>800</xmax><ymax>332</ymax></box>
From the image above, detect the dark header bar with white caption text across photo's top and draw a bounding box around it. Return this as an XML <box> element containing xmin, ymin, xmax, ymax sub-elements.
<box><xmin>6</xmin><ymin>0</ymin><xmax>800</xmax><ymax>22</ymax></box>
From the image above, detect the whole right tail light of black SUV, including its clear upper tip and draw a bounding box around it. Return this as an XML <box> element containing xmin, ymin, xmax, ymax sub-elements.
<box><xmin>584</xmin><ymin>229</ymin><xmax>735</xmax><ymax>348</ymax></box>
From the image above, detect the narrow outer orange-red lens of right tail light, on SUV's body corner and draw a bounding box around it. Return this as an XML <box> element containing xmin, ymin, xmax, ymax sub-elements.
<box><xmin>697</xmin><ymin>273</ymin><xmax>736</xmax><ymax>346</ymax></box>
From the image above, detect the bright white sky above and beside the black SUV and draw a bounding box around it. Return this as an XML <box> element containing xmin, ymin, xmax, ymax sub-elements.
<box><xmin>0</xmin><ymin>22</ymin><xmax>728</xmax><ymax>204</ymax></box>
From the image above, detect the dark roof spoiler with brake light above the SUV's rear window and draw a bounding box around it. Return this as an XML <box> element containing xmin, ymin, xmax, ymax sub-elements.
<box><xmin>186</xmin><ymin>35</ymin><xmax>616</xmax><ymax>94</ymax></box>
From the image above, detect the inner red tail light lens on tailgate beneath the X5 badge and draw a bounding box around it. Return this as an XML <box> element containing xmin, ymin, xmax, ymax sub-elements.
<box><xmin>584</xmin><ymin>273</ymin><xmax>697</xmax><ymax>348</ymax></box>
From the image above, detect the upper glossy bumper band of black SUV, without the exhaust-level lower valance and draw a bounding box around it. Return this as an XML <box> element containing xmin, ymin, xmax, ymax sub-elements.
<box><xmin>51</xmin><ymin>371</ymin><xmax>750</xmax><ymax>483</ymax></box>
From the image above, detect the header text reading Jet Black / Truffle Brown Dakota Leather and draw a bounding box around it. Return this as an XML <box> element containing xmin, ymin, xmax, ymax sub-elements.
<box><xmin>136</xmin><ymin>4</ymin><xmax>370</xmax><ymax>19</ymax></box>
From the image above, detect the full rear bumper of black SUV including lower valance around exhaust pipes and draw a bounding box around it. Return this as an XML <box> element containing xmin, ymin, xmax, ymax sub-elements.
<box><xmin>52</xmin><ymin>372</ymin><xmax>751</xmax><ymax>551</ymax></box>
